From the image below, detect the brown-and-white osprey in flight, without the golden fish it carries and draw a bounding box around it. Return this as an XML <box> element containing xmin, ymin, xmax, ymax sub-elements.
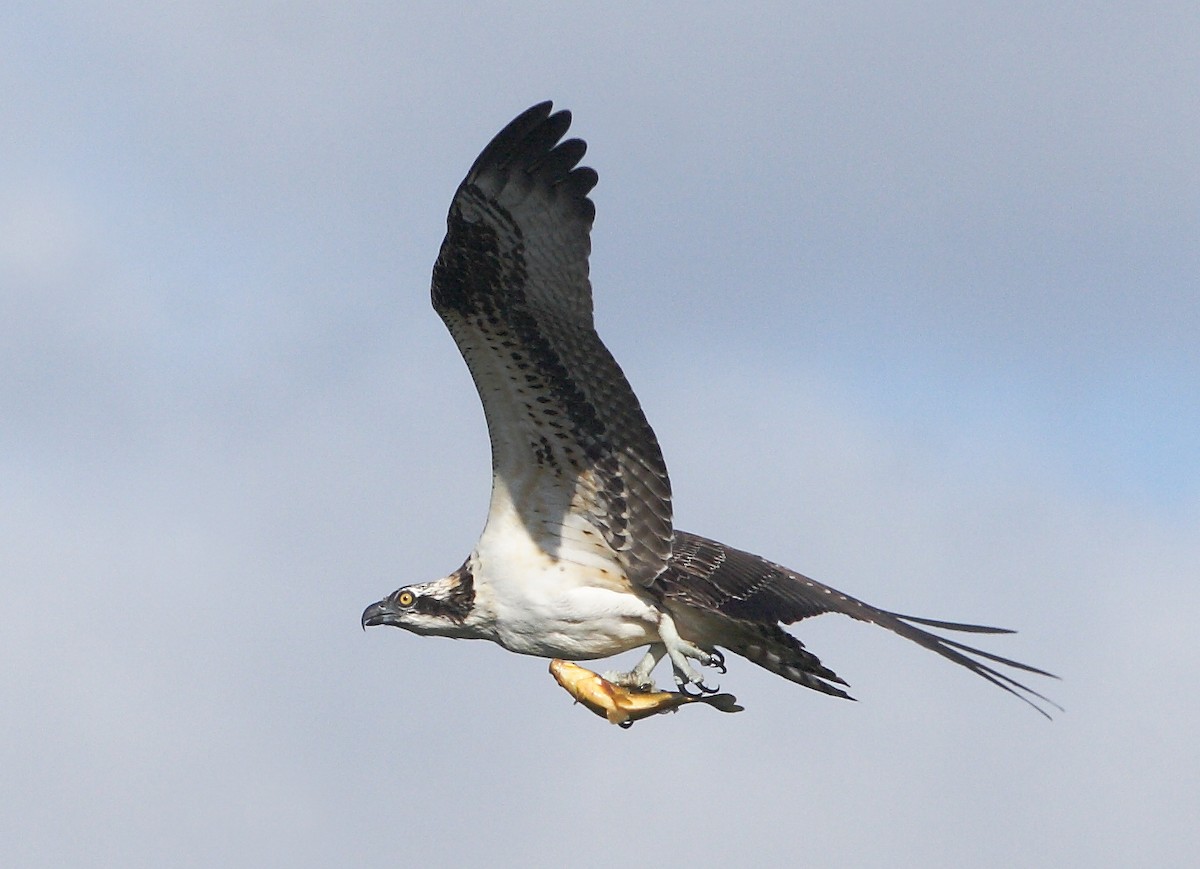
<box><xmin>362</xmin><ymin>102</ymin><xmax>1052</xmax><ymax>714</ymax></box>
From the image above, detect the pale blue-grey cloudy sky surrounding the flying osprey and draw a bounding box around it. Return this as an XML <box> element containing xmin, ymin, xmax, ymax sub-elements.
<box><xmin>0</xmin><ymin>2</ymin><xmax>1200</xmax><ymax>868</ymax></box>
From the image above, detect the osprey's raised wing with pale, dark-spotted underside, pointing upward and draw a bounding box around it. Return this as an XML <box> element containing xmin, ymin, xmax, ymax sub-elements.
<box><xmin>432</xmin><ymin>102</ymin><xmax>672</xmax><ymax>585</ymax></box>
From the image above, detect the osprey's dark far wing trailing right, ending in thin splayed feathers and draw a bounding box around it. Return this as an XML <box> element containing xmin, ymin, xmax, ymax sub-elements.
<box><xmin>654</xmin><ymin>531</ymin><xmax>1057</xmax><ymax>714</ymax></box>
